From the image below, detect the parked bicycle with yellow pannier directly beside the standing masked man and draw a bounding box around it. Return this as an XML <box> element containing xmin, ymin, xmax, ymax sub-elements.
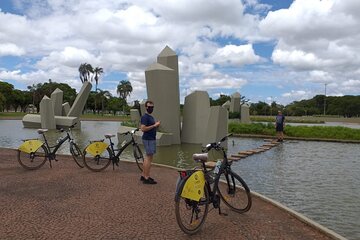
<box><xmin>83</xmin><ymin>128</ymin><xmax>144</xmax><ymax>172</ymax></box>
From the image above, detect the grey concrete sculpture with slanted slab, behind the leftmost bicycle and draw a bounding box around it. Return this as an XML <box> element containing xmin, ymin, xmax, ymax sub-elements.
<box><xmin>22</xmin><ymin>82</ymin><xmax>91</xmax><ymax>129</ymax></box>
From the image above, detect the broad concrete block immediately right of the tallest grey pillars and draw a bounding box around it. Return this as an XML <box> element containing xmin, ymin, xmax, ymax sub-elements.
<box><xmin>181</xmin><ymin>91</ymin><xmax>210</xmax><ymax>144</ymax></box>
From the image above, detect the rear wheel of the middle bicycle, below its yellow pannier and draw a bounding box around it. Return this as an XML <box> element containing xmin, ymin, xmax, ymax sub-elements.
<box><xmin>83</xmin><ymin>145</ymin><xmax>112</xmax><ymax>172</ymax></box>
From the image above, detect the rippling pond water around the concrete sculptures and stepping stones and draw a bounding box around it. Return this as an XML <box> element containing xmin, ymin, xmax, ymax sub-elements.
<box><xmin>0</xmin><ymin>120</ymin><xmax>360</xmax><ymax>239</ymax></box>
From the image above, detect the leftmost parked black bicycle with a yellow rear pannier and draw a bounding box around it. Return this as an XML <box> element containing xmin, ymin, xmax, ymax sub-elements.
<box><xmin>18</xmin><ymin>124</ymin><xmax>84</xmax><ymax>170</ymax></box>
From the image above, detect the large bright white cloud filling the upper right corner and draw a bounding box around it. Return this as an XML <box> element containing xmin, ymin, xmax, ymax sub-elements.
<box><xmin>259</xmin><ymin>0</ymin><xmax>360</xmax><ymax>81</ymax></box>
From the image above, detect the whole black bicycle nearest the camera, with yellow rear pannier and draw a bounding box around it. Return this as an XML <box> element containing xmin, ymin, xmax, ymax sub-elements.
<box><xmin>175</xmin><ymin>135</ymin><xmax>252</xmax><ymax>235</ymax></box>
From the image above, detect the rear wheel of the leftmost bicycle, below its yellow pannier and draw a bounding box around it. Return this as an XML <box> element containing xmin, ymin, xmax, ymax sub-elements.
<box><xmin>18</xmin><ymin>145</ymin><xmax>47</xmax><ymax>170</ymax></box>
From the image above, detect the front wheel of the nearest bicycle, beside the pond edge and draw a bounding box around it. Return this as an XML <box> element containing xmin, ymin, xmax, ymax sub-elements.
<box><xmin>217</xmin><ymin>172</ymin><xmax>251</xmax><ymax>213</ymax></box>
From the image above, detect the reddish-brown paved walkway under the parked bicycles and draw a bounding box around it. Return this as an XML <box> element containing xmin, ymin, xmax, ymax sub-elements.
<box><xmin>0</xmin><ymin>148</ymin><xmax>336</xmax><ymax>240</ymax></box>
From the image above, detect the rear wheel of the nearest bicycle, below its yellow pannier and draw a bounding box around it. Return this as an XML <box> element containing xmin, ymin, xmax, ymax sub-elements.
<box><xmin>175</xmin><ymin>186</ymin><xmax>209</xmax><ymax>235</ymax></box>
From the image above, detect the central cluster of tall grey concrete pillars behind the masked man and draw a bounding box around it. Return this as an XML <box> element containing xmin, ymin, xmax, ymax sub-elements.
<box><xmin>118</xmin><ymin>46</ymin><xmax>229</xmax><ymax>146</ymax></box>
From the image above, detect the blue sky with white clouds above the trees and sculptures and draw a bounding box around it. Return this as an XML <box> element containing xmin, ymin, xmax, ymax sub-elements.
<box><xmin>0</xmin><ymin>0</ymin><xmax>360</xmax><ymax>104</ymax></box>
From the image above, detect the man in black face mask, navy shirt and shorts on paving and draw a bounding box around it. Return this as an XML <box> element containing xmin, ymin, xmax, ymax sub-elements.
<box><xmin>140</xmin><ymin>101</ymin><xmax>160</xmax><ymax>184</ymax></box>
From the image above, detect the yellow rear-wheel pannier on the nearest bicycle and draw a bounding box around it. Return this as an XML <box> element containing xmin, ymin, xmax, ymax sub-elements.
<box><xmin>181</xmin><ymin>171</ymin><xmax>205</xmax><ymax>201</ymax></box>
